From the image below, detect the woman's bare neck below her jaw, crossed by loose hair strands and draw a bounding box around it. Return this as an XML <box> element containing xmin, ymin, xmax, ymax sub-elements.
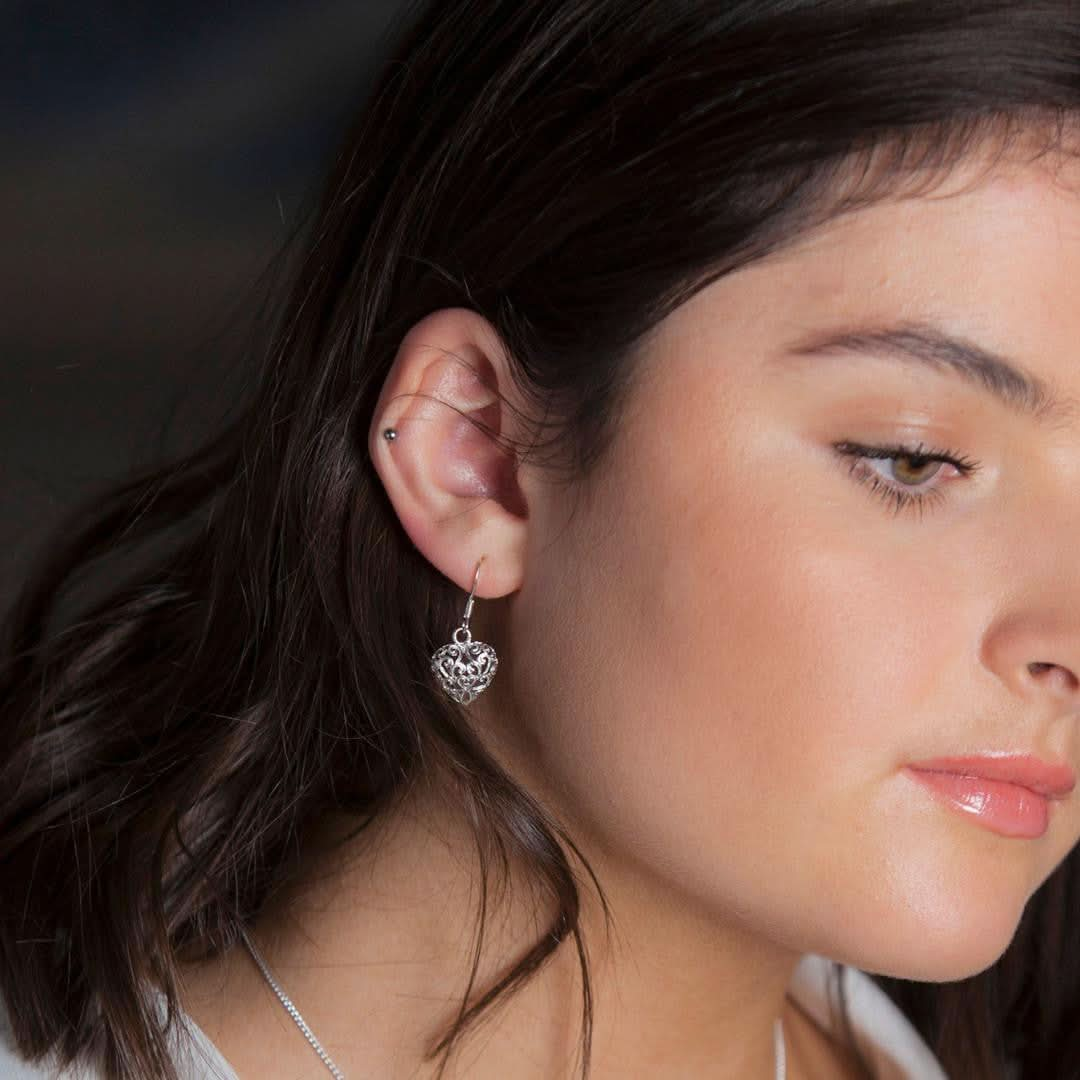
<box><xmin>208</xmin><ymin>777</ymin><xmax>806</xmax><ymax>1080</ymax></box>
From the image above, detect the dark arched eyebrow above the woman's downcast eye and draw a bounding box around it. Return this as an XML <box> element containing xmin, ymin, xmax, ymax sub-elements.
<box><xmin>779</xmin><ymin>322</ymin><xmax>1078</xmax><ymax>423</ymax></box>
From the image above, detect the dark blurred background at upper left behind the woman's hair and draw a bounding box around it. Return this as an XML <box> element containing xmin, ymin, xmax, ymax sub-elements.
<box><xmin>0</xmin><ymin>0</ymin><xmax>405</xmax><ymax>607</ymax></box>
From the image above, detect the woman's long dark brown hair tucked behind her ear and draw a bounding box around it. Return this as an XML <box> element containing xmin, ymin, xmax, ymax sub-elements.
<box><xmin>0</xmin><ymin>0</ymin><xmax>1080</xmax><ymax>1080</ymax></box>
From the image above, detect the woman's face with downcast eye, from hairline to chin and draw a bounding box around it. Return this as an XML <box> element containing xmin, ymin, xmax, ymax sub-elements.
<box><xmin>494</xmin><ymin>147</ymin><xmax>1080</xmax><ymax>981</ymax></box>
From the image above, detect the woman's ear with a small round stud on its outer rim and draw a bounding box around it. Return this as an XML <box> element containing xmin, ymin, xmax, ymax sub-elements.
<box><xmin>368</xmin><ymin>308</ymin><xmax>527</xmax><ymax>598</ymax></box>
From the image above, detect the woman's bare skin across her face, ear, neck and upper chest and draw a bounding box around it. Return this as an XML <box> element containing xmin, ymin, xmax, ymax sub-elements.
<box><xmin>177</xmin><ymin>141</ymin><xmax>1080</xmax><ymax>1080</ymax></box>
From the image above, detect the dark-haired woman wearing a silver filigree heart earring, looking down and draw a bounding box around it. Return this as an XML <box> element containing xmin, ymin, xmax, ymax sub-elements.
<box><xmin>0</xmin><ymin>0</ymin><xmax>1080</xmax><ymax>1080</ymax></box>
